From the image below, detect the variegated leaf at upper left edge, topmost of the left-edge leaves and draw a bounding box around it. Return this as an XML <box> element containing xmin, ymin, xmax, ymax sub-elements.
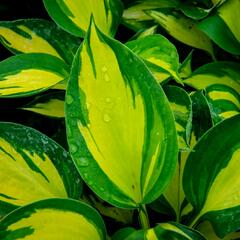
<box><xmin>0</xmin><ymin>19</ymin><xmax>80</xmax><ymax>64</ymax></box>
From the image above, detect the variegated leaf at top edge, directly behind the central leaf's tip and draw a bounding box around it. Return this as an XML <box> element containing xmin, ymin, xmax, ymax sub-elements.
<box><xmin>43</xmin><ymin>0</ymin><xmax>123</xmax><ymax>37</ymax></box>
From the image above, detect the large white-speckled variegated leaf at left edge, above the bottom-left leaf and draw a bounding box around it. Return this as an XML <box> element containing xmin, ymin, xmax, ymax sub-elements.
<box><xmin>0</xmin><ymin>123</ymin><xmax>82</xmax><ymax>214</ymax></box>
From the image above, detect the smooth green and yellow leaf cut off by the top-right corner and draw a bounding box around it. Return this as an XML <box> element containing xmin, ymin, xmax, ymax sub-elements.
<box><xmin>198</xmin><ymin>0</ymin><xmax>240</xmax><ymax>55</ymax></box>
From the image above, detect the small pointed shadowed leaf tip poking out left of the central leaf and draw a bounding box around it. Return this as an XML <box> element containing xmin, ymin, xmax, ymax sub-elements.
<box><xmin>21</xmin><ymin>92</ymin><xmax>65</xmax><ymax>118</ymax></box>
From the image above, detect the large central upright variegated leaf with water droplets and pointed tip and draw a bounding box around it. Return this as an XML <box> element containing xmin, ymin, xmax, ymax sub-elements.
<box><xmin>66</xmin><ymin>20</ymin><xmax>178</xmax><ymax>207</ymax></box>
